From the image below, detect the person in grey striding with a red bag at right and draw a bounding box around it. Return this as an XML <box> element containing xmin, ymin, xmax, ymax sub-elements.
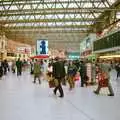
<box><xmin>94</xmin><ymin>67</ymin><xmax>114</xmax><ymax>96</ymax></box>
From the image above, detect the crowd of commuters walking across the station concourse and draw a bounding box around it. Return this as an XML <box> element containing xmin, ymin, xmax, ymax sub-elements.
<box><xmin>0</xmin><ymin>57</ymin><xmax>120</xmax><ymax>97</ymax></box>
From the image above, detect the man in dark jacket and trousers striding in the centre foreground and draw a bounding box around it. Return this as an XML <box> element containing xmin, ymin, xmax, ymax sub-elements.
<box><xmin>53</xmin><ymin>57</ymin><xmax>65</xmax><ymax>97</ymax></box>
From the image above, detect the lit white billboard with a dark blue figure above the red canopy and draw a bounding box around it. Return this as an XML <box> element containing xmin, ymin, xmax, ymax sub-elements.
<box><xmin>36</xmin><ymin>40</ymin><xmax>48</xmax><ymax>55</ymax></box>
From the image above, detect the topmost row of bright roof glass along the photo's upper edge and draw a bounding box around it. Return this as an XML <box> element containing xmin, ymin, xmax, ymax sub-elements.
<box><xmin>0</xmin><ymin>0</ymin><xmax>109</xmax><ymax>10</ymax></box>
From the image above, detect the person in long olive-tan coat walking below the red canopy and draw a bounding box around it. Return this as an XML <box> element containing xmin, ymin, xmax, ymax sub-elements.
<box><xmin>33</xmin><ymin>59</ymin><xmax>41</xmax><ymax>84</ymax></box>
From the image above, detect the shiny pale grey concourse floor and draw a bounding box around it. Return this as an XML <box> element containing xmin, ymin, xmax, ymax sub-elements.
<box><xmin>0</xmin><ymin>71</ymin><xmax>120</xmax><ymax>120</ymax></box>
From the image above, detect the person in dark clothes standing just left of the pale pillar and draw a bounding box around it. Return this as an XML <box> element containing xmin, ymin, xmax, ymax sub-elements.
<box><xmin>79</xmin><ymin>61</ymin><xmax>88</xmax><ymax>87</ymax></box>
